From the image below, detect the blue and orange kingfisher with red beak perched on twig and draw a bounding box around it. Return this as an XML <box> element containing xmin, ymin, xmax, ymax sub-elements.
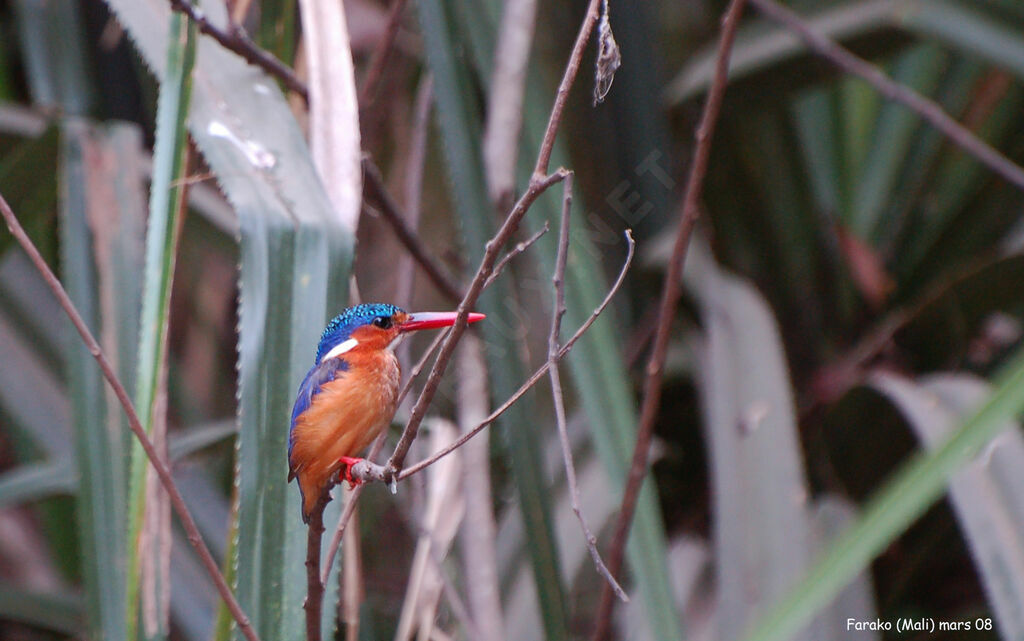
<box><xmin>288</xmin><ymin>303</ymin><xmax>484</xmax><ymax>523</ymax></box>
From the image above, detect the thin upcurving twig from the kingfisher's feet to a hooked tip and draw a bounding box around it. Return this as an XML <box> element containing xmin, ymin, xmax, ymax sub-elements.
<box><xmin>350</xmin><ymin>229</ymin><xmax>636</xmax><ymax>481</ymax></box>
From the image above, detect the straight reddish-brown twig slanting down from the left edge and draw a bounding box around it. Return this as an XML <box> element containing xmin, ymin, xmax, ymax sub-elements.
<box><xmin>0</xmin><ymin>190</ymin><xmax>259</xmax><ymax>641</ymax></box>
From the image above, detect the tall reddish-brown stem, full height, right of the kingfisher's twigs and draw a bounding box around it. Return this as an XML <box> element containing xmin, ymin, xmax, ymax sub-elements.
<box><xmin>594</xmin><ymin>0</ymin><xmax>745</xmax><ymax>641</ymax></box>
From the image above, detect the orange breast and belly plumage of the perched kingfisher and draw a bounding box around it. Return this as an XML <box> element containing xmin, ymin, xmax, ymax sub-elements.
<box><xmin>291</xmin><ymin>350</ymin><xmax>400</xmax><ymax>515</ymax></box>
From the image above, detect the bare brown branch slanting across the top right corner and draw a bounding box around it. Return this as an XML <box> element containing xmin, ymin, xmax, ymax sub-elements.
<box><xmin>751</xmin><ymin>0</ymin><xmax>1024</xmax><ymax>189</ymax></box>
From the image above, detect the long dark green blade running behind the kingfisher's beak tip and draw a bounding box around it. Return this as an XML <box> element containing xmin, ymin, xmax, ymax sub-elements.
<box><xmin>419</xmin><ymin>0</ymin><xmax>568</xmax><ymax>640</ymax></box>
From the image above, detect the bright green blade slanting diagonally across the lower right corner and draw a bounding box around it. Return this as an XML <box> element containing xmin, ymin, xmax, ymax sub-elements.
<box><xmin>746</xmin><ymin>349</ymin><xmax>1024</xmax><ymax>641</ymax></box>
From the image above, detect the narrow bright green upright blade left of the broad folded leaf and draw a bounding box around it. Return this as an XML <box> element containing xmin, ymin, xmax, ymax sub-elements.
<box><xmin>126</xmin><ymin>13</ymin><xmax>197</xmax><ymax>639</ymax></box>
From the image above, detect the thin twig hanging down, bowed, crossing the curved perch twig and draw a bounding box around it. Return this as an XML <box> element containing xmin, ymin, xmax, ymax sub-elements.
<box><xmin>548</xmin><ymin>173</ymin><xmax>630</xmax><ymax>603</ymax></box>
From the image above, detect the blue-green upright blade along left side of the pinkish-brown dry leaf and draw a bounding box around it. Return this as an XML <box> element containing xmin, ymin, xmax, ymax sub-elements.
<box><xmin>60</xmin><ymin>117</ymin><xmax>126</xmax><ymax>641</ymax></box>
